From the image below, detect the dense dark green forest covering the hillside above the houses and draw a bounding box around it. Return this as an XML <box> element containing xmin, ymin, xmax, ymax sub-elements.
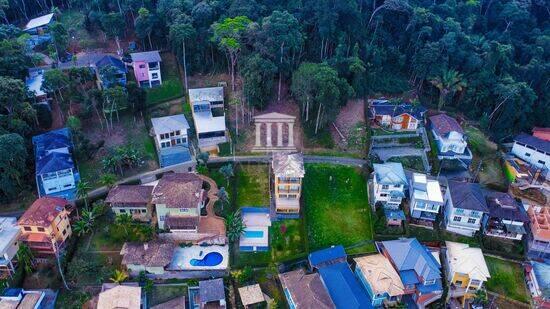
<box><xmin>0</xmin><ymin>0</ymin><xmax>550</xmax><ymax>197</ymax></box>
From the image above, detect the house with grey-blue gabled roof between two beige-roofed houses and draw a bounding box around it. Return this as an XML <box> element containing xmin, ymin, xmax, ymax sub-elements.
<box><xmin>377</xmin><ymin>238</ymin><xmax>443</xmax><ymax>308</ymax></box>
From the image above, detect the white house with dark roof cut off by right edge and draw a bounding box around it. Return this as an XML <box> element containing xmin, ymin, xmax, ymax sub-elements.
<box><xmin>512</xmin><ymin>133</ymin><xmax>550</xmax><ymax>169</ymax></box>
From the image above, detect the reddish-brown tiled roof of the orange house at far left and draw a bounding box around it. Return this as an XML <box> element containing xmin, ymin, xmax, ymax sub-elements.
<box><xmin>18</xmin><ymin>196</ymin><xmax>69</xmax><ymax>227</ymax></box>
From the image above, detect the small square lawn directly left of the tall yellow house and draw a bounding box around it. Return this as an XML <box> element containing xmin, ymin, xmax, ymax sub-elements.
<box><xmin>235</xmin><ymin>164</ymin><xmax>269</xmax><ymax>208</ymax></box>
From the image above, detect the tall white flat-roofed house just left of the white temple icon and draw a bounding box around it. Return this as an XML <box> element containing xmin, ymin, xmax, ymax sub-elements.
<box><xmin>189</xmin><ymin>87</ymin><xmax>227</xmax><ymax>154</ymax></box>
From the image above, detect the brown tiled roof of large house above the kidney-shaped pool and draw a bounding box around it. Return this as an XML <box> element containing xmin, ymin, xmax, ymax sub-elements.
<box><xmin>152</xmin><ymin>173</ymin><xmax>203</xmax><ymax>208</ymax></box>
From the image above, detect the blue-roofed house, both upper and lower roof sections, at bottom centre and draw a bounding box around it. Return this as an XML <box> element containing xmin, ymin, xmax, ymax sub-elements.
<box><xmin>308</xmin><ymin>246</ymin><xmax>373</xmax><ymax>309</ymax></box>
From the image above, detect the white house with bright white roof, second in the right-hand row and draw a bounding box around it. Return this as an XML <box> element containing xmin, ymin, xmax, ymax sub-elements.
<box><xmin>409</xmin><ymin>173</ymin><xmax>444</xmax><ymax>222</ymax></box>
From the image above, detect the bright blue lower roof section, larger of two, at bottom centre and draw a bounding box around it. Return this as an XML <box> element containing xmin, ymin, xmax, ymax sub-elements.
<box><xmin>319</xmin><ymin>262</ymin><xmax>373</xmax><ymax>308</ymax></box>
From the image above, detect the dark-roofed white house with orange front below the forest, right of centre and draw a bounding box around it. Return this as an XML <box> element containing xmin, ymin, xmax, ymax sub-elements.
<box><xmin>368</xmin><ymin>100</ymin><xmax>426</xmax><ymax>131</ymax></box>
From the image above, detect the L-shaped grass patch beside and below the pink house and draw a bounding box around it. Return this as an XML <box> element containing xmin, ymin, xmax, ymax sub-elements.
<box><xmin>147</xmin><ymin>53</ymin><xmax>184</xmax><ymax>106</ymax></box>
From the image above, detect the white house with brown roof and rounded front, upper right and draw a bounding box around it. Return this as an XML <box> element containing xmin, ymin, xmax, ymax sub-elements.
<box><xmin>430</xmin><ymin>114</ymin><xmax>472</xmax><ymax>168</ymax></box>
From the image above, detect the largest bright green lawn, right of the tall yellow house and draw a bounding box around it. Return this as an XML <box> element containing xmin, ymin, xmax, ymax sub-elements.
<box><xmin>302</xmin><ymin>164</ymin><xmax>374</xmax><ymax>252</ymax></box>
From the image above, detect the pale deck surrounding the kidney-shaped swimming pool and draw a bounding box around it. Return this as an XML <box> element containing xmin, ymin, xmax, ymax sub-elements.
<box><xmin>167</xmin><ymin>245</ymin><xmax>229</xmax><ymax>271</ymax></box>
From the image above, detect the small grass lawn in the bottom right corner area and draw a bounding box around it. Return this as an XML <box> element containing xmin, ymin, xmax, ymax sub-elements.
<box><xmin>485</xmin><ymin>256</ymin><xmax>529</xmax><ymax>303</ymax></box>
